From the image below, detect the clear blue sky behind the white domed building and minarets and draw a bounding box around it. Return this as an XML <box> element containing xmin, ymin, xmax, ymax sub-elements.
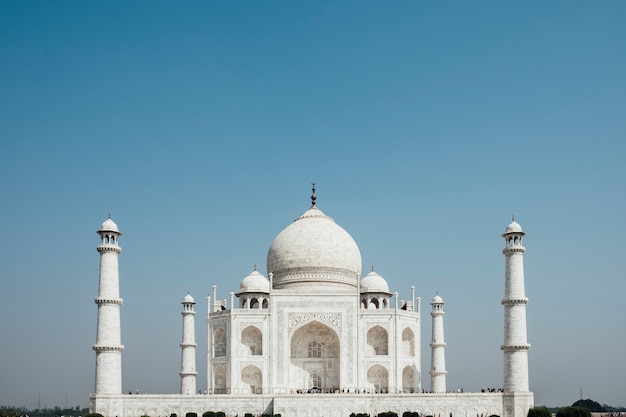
<box><xmin>0</xmin><ymin>1</ymin><xmax>626</xmax><ymax>408</ymax></box>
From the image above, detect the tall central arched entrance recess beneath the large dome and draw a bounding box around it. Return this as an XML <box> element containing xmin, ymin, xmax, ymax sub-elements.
<box><xmin>289</xmin><ymin>321</ymin><xmax>341</xmax><ymax>392</ymax></box>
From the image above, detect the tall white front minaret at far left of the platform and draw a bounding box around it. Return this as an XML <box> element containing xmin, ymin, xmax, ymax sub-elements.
<box><xmin>93</xmin><ymin>214</ymin><xmax>124</xmax><ymax>394</ymax></box>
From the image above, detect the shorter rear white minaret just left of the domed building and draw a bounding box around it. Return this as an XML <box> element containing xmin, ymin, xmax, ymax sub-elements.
<box><xmin>179</xmin><ymin>294</ymin><xmax>198</xmax><ymax>395</ymax></box>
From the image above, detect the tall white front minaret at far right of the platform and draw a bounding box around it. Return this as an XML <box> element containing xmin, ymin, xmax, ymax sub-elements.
<box><xmin>501</xmin><ymin>216</ymin><xmax>530</xmax><ymax>393</ymax></box>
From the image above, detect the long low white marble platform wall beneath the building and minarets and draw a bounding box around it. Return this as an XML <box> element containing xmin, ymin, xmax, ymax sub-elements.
<box><xmin>90</xmin><ymin>393</ymin><xmax>510</xmax><ymax>417</ymax></box>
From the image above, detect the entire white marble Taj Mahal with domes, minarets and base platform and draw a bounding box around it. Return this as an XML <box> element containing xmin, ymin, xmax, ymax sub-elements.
<box><xmin>89</xmin><ymin>184</ymin><xmax>534</xmax><ymax>417</ymax></box>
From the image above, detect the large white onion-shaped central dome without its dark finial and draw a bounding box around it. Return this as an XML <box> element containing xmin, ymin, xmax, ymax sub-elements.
<box><xmin>267</xmin><ymin>204</ymin><xmax>361</xmax><ymax>291</ymax></box>
